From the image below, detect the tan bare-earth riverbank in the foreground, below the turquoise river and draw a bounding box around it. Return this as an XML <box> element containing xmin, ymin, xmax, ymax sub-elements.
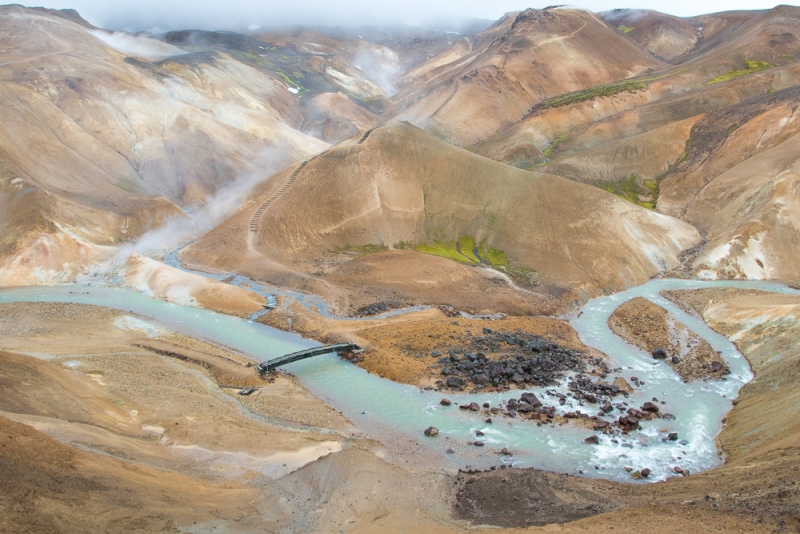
<box><xmin>0</xmin><ymin>282</ymin><xmax>800</xmax><ymax>532</ymax></box>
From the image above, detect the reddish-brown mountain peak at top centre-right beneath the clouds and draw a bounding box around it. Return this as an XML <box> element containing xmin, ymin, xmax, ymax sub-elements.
<box><xmin>388</xmin><ymin>8</ymin><xmax>664</xmax><ymax>149</ymax></box>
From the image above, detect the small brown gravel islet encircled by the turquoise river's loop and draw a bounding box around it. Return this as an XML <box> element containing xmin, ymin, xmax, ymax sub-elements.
<box><xmin>608</xmin><ymin>297</ymin><xmax>729</xmax><ymax>382</ymax></box>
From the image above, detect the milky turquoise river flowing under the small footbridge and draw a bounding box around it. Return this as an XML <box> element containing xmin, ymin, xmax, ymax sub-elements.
<box><xmin>0</xmin><ymin>279</ymin><xmax>800</xmax><ymax>481</ymax></box>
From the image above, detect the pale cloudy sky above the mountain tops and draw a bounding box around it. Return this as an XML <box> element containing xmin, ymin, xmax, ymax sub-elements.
<box><xmin>27</xmin><ymin>0</ymin><xmax>792</xmax><ymax>31</ymax></box>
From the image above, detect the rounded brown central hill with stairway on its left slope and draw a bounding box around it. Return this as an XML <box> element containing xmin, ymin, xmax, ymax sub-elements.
<box><xmin>182</xmin><ymin>123</ymin><xmax>699</xmax><ymax>314</ymax></box>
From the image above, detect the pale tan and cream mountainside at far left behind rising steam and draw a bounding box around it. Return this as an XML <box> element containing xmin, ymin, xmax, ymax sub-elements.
<box><xmin>0</xmin><ymin>6</ymin><xmax>327</xmax><ymax>284</ymax></box>
